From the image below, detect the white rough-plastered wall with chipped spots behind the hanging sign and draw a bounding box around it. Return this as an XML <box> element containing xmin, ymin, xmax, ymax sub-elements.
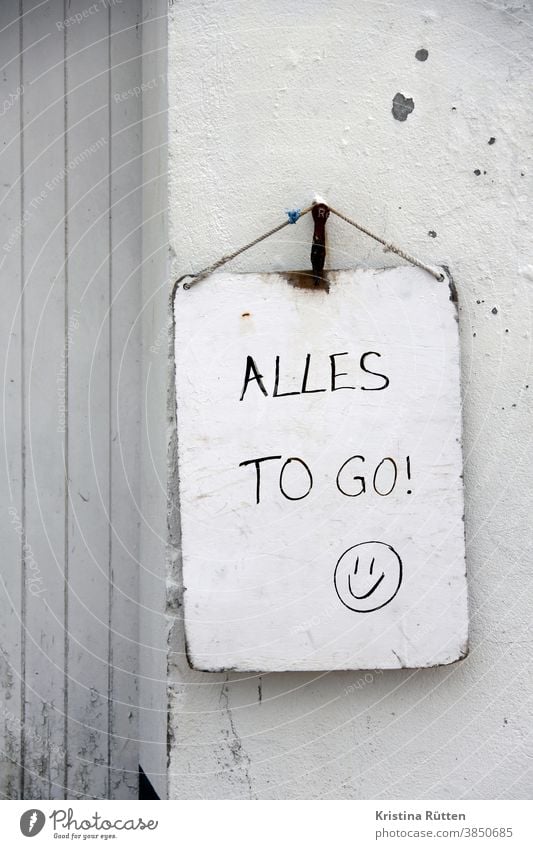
<box><xmin>169</xmin><ymin>0</ymin><xmax>533</xmax><ymax>798</ymax></box>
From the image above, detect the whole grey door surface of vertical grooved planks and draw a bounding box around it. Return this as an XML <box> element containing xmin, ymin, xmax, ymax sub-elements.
<box><xmin>0</xmin><ymin>0</ymin><xmax>142</xmax><ymax>798</ymax></box>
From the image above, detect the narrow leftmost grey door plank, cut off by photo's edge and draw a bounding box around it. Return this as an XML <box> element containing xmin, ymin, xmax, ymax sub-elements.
<box><xmin>0</xmin><ymin>0</ymin><xmax>24</xmax><ymax>799</ymax></box>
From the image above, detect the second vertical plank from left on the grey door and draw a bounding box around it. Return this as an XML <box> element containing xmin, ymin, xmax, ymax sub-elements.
<box><xmin>21</xmin><ymin>0</ymin><xmax>68</xmax><ymax>799</ymax></box>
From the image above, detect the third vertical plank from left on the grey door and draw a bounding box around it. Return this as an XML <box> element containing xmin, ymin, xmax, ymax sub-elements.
<box><xmin>67</xmin><ymin>0</ymin><xmax>110</xmax><ymax>799</ymax></box>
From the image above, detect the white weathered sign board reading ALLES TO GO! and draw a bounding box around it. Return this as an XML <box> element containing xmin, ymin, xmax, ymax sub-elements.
<box><xmin>174</xmin><ymin>267</ymin><xmax>468</xmax><ymax>671</ymax></box>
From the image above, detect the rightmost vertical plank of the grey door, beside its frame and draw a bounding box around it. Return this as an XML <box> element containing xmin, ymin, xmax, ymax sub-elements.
<box><xmin>109</xmin><ymin>3</ymin><xmax>142</xmax><ymax>799</ymax></box>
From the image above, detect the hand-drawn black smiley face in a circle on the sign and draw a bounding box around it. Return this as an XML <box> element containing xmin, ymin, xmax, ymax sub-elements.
<box><xmin>334</xmin><ymin>540</ymin><xmax>402</xmax><ymax>613</ymax></box>
